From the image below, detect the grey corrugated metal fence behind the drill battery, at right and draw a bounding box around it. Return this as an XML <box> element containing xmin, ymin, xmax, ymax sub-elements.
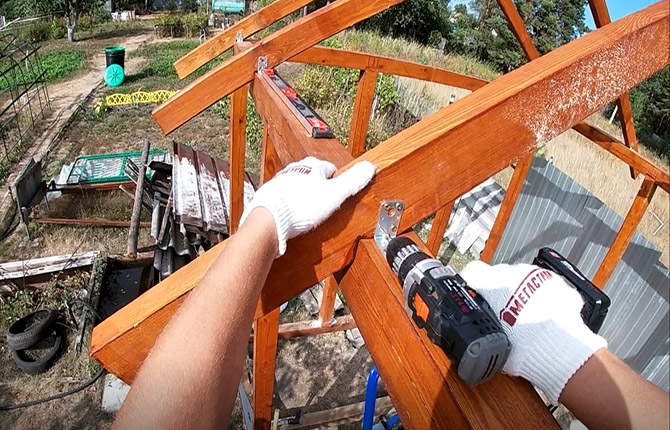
<box><xmin>493</xmin><ymin>157</ymin><xmax>670</xmax><ymax>391</ymax></box>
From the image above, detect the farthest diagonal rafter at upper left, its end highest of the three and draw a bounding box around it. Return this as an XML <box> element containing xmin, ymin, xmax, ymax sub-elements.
<box><xmin>174</xmin><ymin>0</ymin><xmax>313</xmax><ymax>79</ymax></box>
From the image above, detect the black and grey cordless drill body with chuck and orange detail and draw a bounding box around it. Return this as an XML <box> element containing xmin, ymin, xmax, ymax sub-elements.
<box><xmin>386</xmin><ymin>237</ymin><xmax>510</xmax><ymax>385</ymax></box>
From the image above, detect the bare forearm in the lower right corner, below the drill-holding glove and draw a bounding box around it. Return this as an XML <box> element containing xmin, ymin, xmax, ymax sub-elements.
<box><xmin>560</xmin><ymin>348</ymin><xmax>670</xmax><ymax>430</ymax></box>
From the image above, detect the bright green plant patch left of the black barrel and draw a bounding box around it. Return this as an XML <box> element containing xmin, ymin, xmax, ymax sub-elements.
<box><xmin>0</xmin><ymin>50</ymin><xmax>86</xmax><ymax>91</ymax></box>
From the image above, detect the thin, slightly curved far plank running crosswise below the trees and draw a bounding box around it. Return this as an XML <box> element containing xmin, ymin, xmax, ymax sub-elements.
<box><xmin>290</xmin><ymin>46</ymin><xmax>488</xmax><ymax>91</ymax></box>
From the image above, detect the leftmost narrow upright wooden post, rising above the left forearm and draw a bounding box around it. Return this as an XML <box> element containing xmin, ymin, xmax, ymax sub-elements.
<box><xmin>230</xmin><ymin>85</ymin><xmax>249</xmax><ymax>234</ymax></box>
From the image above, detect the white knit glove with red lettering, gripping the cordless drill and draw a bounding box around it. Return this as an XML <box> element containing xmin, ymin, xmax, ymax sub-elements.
<box><xmin>461</xmin><ymin>261</ymin><xmax>607</xmax><ymax>404</ymax></box>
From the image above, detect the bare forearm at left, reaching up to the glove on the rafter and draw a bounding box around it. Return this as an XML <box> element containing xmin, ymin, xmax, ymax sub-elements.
<box><xmin>115</xmin><ymin>208</ymin><xmax>277</xmax><ymax>429</ymax></box>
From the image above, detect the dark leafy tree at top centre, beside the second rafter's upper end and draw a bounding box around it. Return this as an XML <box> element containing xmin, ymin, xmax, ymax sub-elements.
<box><xmin>359</xmin><ymin>0</ymin><xmax>451</xmax><ymax>44</ymax></box>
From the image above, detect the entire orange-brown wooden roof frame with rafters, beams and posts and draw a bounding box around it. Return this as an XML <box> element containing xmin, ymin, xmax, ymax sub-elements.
<box><xmin>91</xmin><ymin>0</ymin><xmax>670</xmax><ymax>428</ymax></box>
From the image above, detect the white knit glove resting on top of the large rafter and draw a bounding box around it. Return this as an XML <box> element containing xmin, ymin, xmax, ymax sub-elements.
<box><xmin>240</xmin><ymin>157</ymin><xmax>375</xmax><ymax>256</ymax></box>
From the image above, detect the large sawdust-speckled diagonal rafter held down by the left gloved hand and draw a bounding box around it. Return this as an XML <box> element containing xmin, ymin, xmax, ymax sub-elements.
<box><xmin>91</xmin><ymin>1</ymin><xmax>670</xmax><ymax>382</ymax></box>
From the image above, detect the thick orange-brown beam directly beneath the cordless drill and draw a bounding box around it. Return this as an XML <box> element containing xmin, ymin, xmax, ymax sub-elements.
<box><xmin>340</xmin><ymin>234</ymin><xmax>558</xmax><ymax>429</ymax></box>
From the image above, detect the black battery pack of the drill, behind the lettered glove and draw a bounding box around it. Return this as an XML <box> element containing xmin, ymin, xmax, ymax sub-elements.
<box><xmin>533</xmin><ymin>248</ymin><xmax>611</xmax><ymax>333</ymax></box>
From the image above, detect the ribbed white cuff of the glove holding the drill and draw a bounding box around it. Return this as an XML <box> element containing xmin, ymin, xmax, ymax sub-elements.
<box><xmin>519</xmin><ymin>320</ymin><xmax>607</xmax><ymax>405</ymax></box>
